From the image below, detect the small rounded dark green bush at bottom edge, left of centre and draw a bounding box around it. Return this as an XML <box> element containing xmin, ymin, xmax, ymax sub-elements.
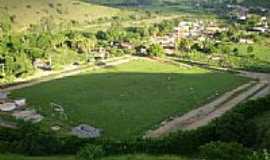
<box><xmin>77</xmin><ymin>144</ymin><xmax>105</xmax><ymax>160</ymax></box>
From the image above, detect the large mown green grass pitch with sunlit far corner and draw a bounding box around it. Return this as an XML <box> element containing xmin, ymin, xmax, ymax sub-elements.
<box><xmin>11</xmin><ymin>60</ymin><xmax>247</xmax><ymax>139</ymax></box>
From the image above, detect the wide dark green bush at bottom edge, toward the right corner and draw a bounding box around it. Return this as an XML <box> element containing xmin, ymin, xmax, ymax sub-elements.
<box><xmin>200</xmin><ymin>142</ymin><xmax>251</xmax><ymax>160</ymax></box>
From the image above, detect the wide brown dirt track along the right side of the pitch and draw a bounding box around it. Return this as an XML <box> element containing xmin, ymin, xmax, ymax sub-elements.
<box><xmin>144</xmin><ymin>62</ymin><xmax>270</xmax><ymax>138</ymax></box>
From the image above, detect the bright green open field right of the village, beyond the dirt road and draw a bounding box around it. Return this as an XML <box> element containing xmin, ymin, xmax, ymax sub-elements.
<box><xmin>180</xmin><ymin>37</ymin><xmax>270</xmax><ymax>73</ymax></box>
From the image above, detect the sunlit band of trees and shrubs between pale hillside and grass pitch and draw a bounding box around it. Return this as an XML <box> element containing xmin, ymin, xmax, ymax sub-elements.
<box><xmin>0</xmin><ymin>15</ymin><xmax>171</xmax><ymax>82</ymax></box>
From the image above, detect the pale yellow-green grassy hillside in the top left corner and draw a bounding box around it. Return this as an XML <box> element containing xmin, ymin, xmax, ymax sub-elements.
<box><xmin>0</xmin><ymin>0</ymin><xmax>121</xmax><ymax>29</ymax></box>
